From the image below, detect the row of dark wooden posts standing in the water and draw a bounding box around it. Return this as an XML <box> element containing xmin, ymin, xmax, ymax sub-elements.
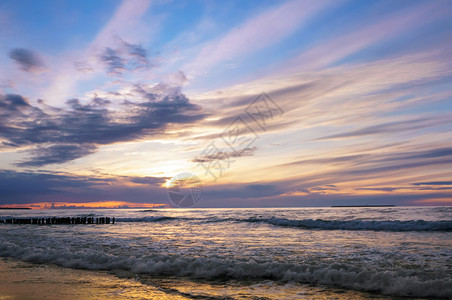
<box><xmin>0</xmin><ymin>217</ymin><xmax>115</xmax><ymax>225</ymax></box>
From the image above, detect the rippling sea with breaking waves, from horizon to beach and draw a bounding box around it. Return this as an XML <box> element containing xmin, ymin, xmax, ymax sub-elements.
<box><xmin>0</xmin><ymin>207</ymin><xmax>452</xmax><ymax>299</ymax></box>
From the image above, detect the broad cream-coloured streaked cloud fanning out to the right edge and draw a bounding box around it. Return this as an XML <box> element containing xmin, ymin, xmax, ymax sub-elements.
<box><xmin>191</xmin><ymin>49</ymin><xmax>451</xmax><ymax>145</ymax></box>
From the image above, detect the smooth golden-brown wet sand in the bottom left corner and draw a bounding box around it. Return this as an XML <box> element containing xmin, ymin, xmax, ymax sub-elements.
<box><xmin>0</xmin><ymin>259</ymin><xmax>187</xmax><ymax>300</ymax></box>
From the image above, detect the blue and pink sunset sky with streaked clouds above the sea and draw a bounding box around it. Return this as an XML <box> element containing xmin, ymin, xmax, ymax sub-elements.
<box><xmin>0</xmin><ymin>0</ymin><xmax>452</xmax><ymax>208</ymax></box>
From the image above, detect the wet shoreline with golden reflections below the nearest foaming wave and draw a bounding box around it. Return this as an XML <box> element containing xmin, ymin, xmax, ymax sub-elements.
<box><xmin>0</xmin><ymin>257</ymin><xmax>400</xmax><ymax>300</ymax></box>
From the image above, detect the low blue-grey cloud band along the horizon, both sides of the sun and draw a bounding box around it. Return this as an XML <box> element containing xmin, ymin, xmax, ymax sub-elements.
<box><xmin>0</xmin><ymin>170</ymin><xmax>450</xmax><ymax>207</ymax></box>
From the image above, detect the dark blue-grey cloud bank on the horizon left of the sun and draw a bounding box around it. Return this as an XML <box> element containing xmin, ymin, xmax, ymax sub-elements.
<box><xmin>0</xmin><ymin>170</ymin><xmax>167</xmax><ymax>204</ymax></box>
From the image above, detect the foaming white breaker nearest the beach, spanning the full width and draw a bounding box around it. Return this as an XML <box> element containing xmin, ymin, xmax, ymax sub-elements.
<box><xmin>0</xmin><ymin>242</ymin><xmax>452</xmax><ymax>298</ymax></box>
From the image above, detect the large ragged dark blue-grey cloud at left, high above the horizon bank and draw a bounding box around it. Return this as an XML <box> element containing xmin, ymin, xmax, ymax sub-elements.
<box><xmin>0</xmin><ymin>85</ymin><xmax>207</xmax><ymax>166</ymax></box>
